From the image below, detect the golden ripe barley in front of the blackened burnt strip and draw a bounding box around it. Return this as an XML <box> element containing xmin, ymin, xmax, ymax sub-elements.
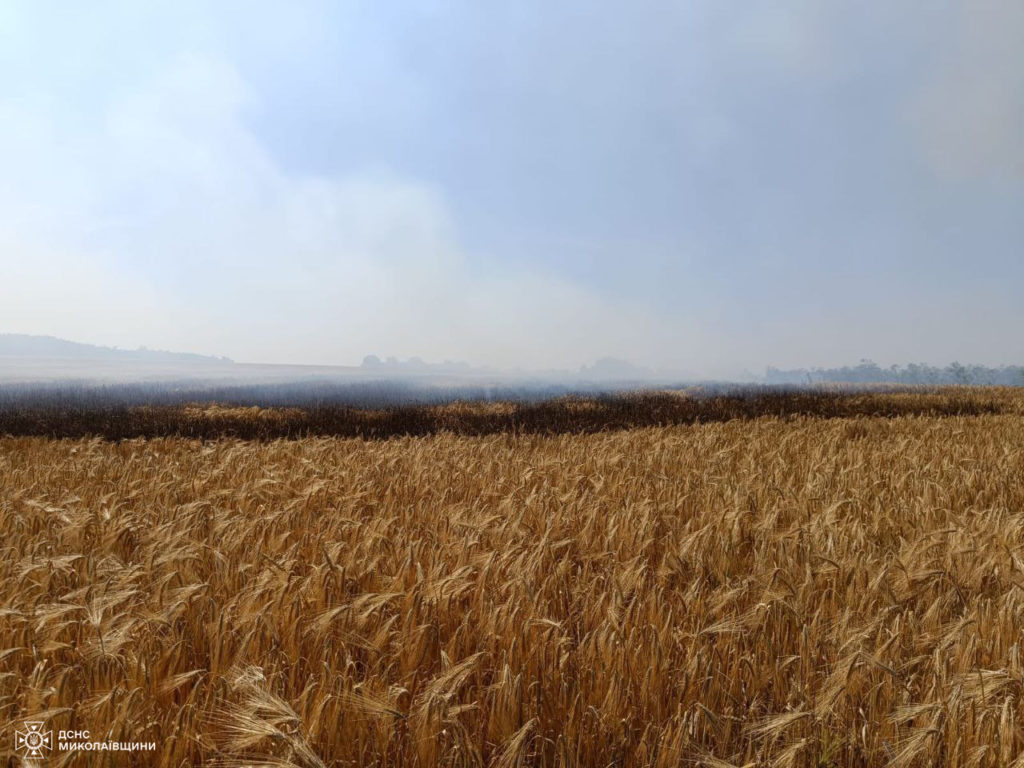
<box><xmin>0</xmin><ymin>392</ymin><xmax>1024</xmax><ymax>768</ymax></box>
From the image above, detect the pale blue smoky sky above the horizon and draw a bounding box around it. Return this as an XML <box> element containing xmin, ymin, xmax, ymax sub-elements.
<box><xmin>0</xmin><ymin>0</ymin><xmax>1024</xmax><ymax>375</ymax></box>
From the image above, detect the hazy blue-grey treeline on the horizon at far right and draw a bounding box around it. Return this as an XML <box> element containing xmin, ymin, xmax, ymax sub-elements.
<box><xmin>765</xmin><ymin>360</ymin><xmax>1024</xmax><ymax>387</ymax></box>
